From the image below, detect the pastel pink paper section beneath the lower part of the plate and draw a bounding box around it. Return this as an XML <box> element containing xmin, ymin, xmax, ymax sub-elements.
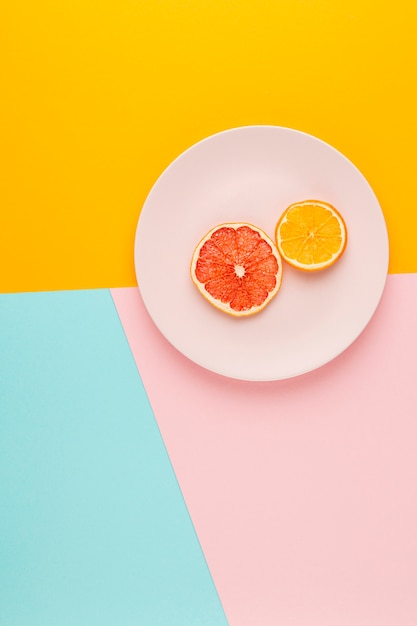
<box><xmin>112</xmin><ymin>274</ymin><xmax>417</xmax><ymax>626</ymax></box>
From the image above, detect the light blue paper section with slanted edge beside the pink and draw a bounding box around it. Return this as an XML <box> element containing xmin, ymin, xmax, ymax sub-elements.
<box><xmin>0</xmin><ymin>290</ymin><xmax>226</xmax><ymax>626</ymax></box>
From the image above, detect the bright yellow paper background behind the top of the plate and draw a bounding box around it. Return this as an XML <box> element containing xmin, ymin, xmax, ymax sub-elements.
<box><xmin>0</xmin><ymin>0</ymin><xmax>417</xmax><ymax>292</ymax></box>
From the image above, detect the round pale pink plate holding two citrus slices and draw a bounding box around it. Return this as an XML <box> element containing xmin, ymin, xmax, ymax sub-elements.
<box><xmin>135</xmin><ymin>126</ymin><xmax>389</xmax><ymax>380</ymax></box>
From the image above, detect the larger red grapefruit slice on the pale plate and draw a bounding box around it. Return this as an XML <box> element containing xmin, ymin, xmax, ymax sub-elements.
<box><xmin>191</xmin><ymin>223</ymin><xmax>282</xmax><ymax>317</ymax></box>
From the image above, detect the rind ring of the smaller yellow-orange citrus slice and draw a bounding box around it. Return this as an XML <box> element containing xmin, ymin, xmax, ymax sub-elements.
<box><xmin>275</xmin><ymin>200</ymin><xmax>348</xmax><ymax>272</ymax></box>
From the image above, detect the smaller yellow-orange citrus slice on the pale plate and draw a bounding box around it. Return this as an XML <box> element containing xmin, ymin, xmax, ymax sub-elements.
<box><xmin>275</xmin><ymin>200</ymin><xmax>347</xmax><ymax>271</ymax></box>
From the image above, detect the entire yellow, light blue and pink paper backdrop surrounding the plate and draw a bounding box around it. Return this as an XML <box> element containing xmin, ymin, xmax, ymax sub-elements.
<box><xmin>0</xmin><ymin>0</ymin><xmax>417</xmax><ymax>626</ymax></box>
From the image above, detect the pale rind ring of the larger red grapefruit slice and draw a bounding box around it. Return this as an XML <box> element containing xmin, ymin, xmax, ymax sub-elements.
<box><xmin>190</xmin><ymin>222</ymin><xmax>283</xmax><ymax>317</ymax></box>
